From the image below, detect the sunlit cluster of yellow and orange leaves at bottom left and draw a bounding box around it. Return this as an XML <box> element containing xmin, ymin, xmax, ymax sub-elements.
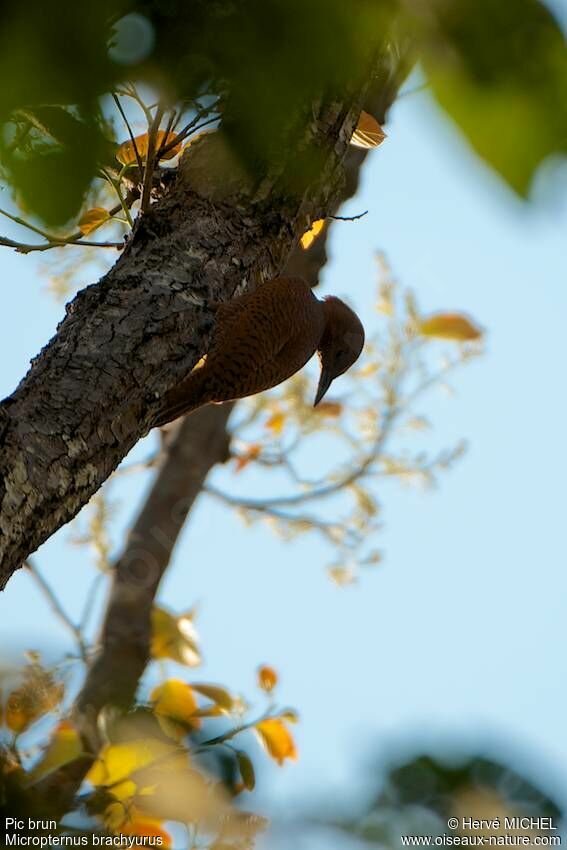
<box><xmin>0</xmin><ymin>636</ymin><xmax>297</xmax><ymax>850</ymax></box>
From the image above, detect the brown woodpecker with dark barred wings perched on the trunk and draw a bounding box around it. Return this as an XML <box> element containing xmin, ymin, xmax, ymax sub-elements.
<box><xmin>152</xmin><ymin>277</ymin><xmax>364</xmax><ymax>427</ymax></box>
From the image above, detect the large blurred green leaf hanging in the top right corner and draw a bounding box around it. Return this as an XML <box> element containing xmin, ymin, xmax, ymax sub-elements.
<box><xmin>425</xmin><ymin>0</ymin><xmax>567</xmax><ymax>196</ymax></box>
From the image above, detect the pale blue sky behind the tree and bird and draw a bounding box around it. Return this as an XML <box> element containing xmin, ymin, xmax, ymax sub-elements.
<box><xmin>0</xmin><ymin>63</ymin><xmax>567</xmax><ymax>832</ymax></box>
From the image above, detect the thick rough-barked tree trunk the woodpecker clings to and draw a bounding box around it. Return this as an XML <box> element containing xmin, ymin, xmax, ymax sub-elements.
<box><xmin>0</xmin><ymin>90</ymin><xmax>364</xmax><ymax>588</ymax></box>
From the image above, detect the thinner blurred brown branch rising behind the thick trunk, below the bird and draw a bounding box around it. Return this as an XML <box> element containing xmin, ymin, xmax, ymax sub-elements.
<box><xmin>77</xmin><ymin>404</ymin><xmax>232</xmax><ymax>715</ymax></box>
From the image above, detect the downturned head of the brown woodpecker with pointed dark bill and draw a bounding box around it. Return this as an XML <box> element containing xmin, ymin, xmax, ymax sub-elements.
<box><xmin>314</xmin><ymin>296</ymin><xmax>364</xmax><ymax>406</ymax></box>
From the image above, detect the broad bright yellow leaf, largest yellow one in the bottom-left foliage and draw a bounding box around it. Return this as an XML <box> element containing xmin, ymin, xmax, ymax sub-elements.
<box><xmin>86</xmin><ymin>738</ymin><xmax>178</xmax><ymax>786</ymax></box>
